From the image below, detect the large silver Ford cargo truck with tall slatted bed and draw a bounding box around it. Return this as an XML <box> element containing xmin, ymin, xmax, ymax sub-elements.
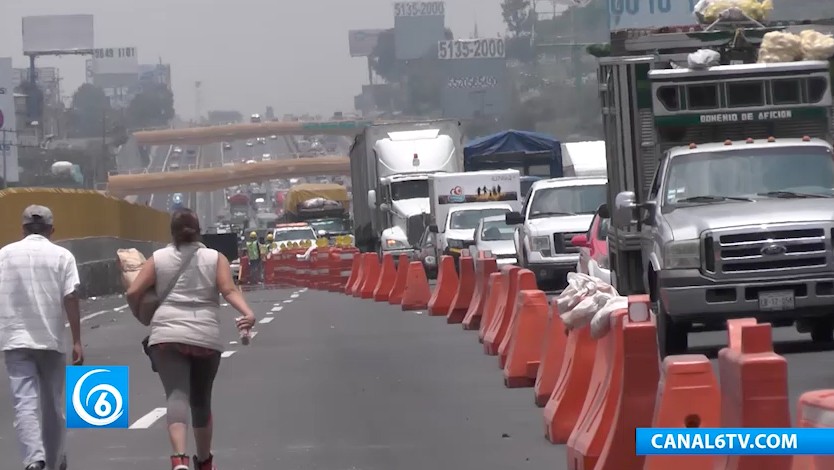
<box><xmin>598</xmin><ymin>15</ymin><xmax>834</xmax><ymax>356</ymax></box>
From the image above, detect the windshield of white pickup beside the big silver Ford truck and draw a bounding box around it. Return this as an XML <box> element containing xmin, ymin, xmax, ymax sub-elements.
<box><xmin>528</xmin><ymin>184</ymin><xmax>608</xmax><ymax>219</ymax></box>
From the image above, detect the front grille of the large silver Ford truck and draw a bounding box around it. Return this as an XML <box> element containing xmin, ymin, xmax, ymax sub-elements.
<box><xmin>704</xmin><ymin>226</ymin><xmax>831</xmax><ymax>276</ymax></box>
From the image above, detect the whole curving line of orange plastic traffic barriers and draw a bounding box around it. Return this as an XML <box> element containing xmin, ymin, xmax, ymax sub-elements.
<box><xmin>269</xmin><ymin>248</ymin><xmax>834</xmax><ymax>470</ymax></box>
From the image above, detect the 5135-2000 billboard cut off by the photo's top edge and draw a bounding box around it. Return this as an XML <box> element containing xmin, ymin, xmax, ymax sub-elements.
<box><xmin>394</xmin><ymin>1</ymin><xmax>446</xmax><ymax>60</ymax></box>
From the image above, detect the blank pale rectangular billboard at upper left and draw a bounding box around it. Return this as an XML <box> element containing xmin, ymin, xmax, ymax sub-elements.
<box><xmin>23</xmin><ymin>15</ymin><xmax>95</xmax><ymax>55</ymax></box>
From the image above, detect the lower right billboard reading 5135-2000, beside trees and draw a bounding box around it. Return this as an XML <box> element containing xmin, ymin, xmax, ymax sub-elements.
<box><xmin>437</xmin><ymin>38</ymin><xmax>511</xmax><ymax>119</ymax></box>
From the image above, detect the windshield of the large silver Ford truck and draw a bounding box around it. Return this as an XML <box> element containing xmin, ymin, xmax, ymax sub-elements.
<box><xmin>663</xmin><ymin>146</ymin><xmax>834</xmax><ymax>204</ymax></box>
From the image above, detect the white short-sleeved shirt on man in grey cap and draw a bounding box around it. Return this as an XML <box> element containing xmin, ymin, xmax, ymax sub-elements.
<box><xmin>0</xmin><ymin>235</ymin><xmax>81</xmax><ymax>352</ymax></box>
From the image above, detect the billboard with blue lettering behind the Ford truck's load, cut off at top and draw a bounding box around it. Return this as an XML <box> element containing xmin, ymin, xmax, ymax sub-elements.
<box><xmin>607</xmin><ymin>0</ymin><xmax>831</xmax><ymax>31</ymax></box>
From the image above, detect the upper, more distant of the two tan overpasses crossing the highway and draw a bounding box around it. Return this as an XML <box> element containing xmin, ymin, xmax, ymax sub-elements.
<box><xmin>133</xmin><ymin>120</ymin><xmax>375</xmax><ymax>145</ymax></box>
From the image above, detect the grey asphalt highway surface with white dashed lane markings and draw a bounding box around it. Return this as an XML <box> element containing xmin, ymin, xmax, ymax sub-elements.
<box><xmin>0</xmin><ymin>289</ymin><xmax>832</xmax><ymax>470</ymax></box>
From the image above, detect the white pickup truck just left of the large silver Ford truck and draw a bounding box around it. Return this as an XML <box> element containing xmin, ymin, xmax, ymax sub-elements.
<box><xmin>506</xmin><ymin>176</ymin><xmax>608</xmax><ymax>286</ymax></box>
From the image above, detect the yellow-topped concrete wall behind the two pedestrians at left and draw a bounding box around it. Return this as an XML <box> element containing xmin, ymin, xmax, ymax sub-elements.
<box><xmin>0</xmin><ymin>188</ymin><xmax>170</xmax><ymax>297</ymax></box>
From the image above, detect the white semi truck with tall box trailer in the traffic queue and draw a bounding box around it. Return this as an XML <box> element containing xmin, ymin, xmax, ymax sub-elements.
<box><xmin>350</xmin><ymin>120</ymin><xmax>463</xmax><ymax>257</ymax></box>
